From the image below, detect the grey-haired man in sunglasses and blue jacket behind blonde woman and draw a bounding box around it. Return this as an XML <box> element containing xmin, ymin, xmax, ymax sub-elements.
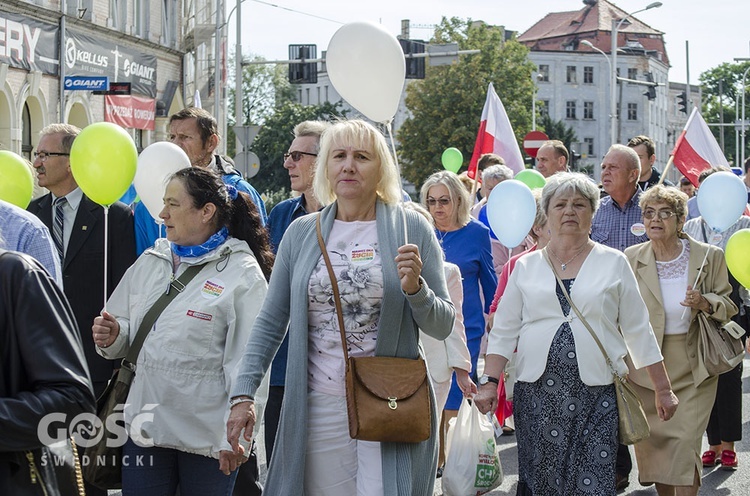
<box><xmin>263</xmin><ymin>121</ymin><xmax>329</xmax><ymax>463</ymax></box>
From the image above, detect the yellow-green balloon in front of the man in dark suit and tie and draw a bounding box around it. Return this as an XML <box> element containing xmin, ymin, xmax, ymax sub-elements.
<box><xmin>70</xmin><ymin>122</ymin><xmax>138</xmax><ymax>205</ymax></box>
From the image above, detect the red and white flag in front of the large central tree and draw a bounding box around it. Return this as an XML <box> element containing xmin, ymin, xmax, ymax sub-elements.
<box><xmin>468</xmin><ymin>83</ymin><xmax>526</xmax><ymax>179</ymax></box>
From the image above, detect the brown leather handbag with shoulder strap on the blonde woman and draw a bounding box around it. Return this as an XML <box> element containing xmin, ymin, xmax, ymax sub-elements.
<box><xmin>316</xmin><ymin>214</ymin><xmax>432</xmax><ymax>443</ymax></box>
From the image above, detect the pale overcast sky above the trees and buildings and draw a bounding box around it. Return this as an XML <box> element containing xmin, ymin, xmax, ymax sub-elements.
<box><xmin>225</xmin><ymin>0</ymin><xmax>750</xmax><ymax>84</ymax></box>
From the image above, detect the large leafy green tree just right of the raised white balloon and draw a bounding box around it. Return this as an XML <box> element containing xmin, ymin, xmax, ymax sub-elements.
<box><xmin>398</xmin><ymin>17</ymin><xmax>536</xmax><ymax>185</ymax></box>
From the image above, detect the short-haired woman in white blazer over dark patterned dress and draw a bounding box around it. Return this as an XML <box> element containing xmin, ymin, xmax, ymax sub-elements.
<box><xmin>476</xmin><ymin>172</ymin><xmax>677</xmax><ymax>496</ymax></box>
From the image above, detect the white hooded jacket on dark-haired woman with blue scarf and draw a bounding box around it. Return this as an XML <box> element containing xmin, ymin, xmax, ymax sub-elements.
<box><xmin>97</xmin><ymin>237</ymin><xmax>268</xmax><ymax>458</ymax></box>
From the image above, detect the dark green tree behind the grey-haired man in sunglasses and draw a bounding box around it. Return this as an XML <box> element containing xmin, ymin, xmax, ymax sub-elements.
<box><xmin>251</xmin><ymin>101</ymin><xmax>346</xmax><ymax>202</ymax></box>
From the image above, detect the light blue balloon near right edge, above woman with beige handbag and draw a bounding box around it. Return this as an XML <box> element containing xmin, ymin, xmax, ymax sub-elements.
<box><xmin>698</xmin><ymin>171</ymin><xmax>747</xmax><ymax>232</ymax></box>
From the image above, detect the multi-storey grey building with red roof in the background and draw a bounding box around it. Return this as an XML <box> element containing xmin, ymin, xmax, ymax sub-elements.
<box><xmin>518</xmin><ymin>0</ymin><xmax>671</xmax><ymax>179</ymax></box>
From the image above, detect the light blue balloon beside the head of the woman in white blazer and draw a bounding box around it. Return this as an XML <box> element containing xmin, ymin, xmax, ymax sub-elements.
<box><xmin>487</xmin><ymin>179</ymin><xmax>536</xmax><ymax>248</ymax></box>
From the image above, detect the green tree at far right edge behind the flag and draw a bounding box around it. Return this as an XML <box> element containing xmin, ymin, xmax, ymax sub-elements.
<box><xmin>699</xmin><ymin>62</ymin><xmax>750</xmax><ymax>166</ymax></box>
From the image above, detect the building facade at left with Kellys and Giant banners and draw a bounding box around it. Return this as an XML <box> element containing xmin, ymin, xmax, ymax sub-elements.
<box><xmin>0</xmin><ymin>0</ymin><xmax>197</xmax><ymax>160</ymax></box>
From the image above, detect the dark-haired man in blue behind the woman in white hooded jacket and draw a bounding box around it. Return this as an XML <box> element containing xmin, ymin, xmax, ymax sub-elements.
<box><xmin>135</xmin><ymin>107</ymin><xmax>268</xmax><ymax>255</ymax></box>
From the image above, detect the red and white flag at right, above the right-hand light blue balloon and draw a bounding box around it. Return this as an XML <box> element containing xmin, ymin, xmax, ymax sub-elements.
<box><xmin>672</xmin><ymin>107</ymin><xmax>729</xmax><ymax>187</ymax></box>
